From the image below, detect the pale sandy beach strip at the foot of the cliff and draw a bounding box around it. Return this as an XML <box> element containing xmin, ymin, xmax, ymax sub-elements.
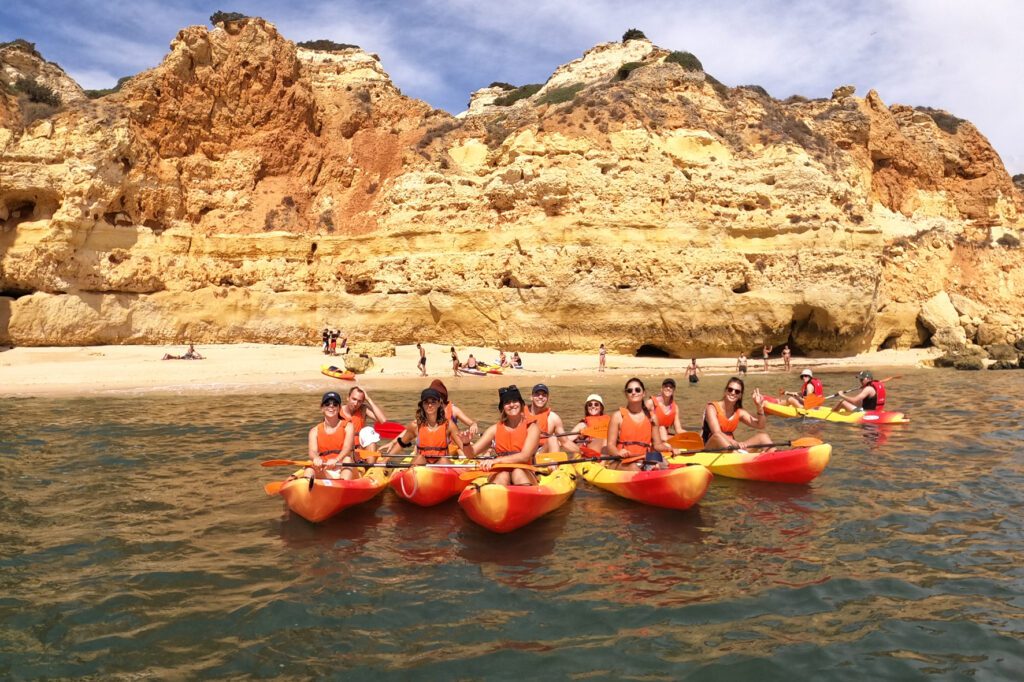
<box><xmin>0</xmin><ymin>343</ymin><xmax>936</xmax><ymax>397</ymax></box>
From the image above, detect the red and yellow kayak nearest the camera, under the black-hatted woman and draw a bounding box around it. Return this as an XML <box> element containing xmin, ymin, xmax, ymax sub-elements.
<box><xmin>459</xmin><ymin>467</ymin><xmax>575</xmax><ymax>532</ymax></box>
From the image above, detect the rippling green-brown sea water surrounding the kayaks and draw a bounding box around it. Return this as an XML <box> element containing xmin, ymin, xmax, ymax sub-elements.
<box><xmin>0</xmin><ymin>371</ymin><xmax>1024</xmax><ymax>681</ymax></box>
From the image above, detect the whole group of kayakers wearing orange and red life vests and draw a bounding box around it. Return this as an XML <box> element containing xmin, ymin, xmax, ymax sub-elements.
<box><xmin>302</xmin><ymin>369</ymin><xmax>885</xmax><ymax>486</ymax></box>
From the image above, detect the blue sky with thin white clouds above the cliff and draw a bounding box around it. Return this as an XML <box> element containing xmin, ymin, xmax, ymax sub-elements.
<box><xmin>6</xmin><ymin>0</ymin><xmax>1024</xmax><ymax>173</ymax></box>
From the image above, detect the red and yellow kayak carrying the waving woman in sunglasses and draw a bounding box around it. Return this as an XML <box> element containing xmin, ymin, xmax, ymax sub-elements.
<box><xmin>668</xmin><ymin>442</ymin><xmax>831</xmax><ymax>483</ymax></box>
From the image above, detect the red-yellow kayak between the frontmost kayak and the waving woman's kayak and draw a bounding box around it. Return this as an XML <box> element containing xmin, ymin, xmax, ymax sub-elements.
<box><xmin>575</xmin><ymin>462</ymin><xmax>712</xmax><ymax>509</ymax></box>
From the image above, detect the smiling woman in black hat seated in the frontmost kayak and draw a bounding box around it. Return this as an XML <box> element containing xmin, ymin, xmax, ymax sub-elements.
<box><xmin>472</xmin><ymin>384</ymin><xmax>541</xmax><ymax>485</ymax></box>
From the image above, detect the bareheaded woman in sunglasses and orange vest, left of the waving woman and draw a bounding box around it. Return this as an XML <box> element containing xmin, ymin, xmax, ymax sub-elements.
<box><xmin>604</xmin><ymin>377</ymin><xmax>672</xmax><ymax>469</ymax></box>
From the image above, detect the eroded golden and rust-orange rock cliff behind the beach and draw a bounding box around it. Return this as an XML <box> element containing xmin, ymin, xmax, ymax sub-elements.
<box><xmin>0</xmin><ymin>18</ymin><xmax>1024</xmax><ymax>356</ymax></box>
